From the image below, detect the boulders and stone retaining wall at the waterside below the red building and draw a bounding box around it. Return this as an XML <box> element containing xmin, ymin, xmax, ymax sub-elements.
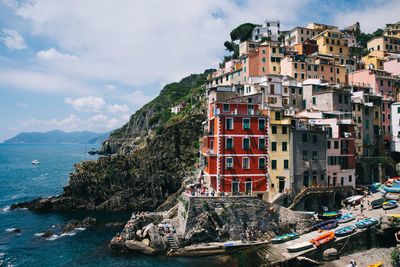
<box><xmin>110</xmin><ymin>194</ymin><xmax>314</xmax><ymax>256</ymax></box>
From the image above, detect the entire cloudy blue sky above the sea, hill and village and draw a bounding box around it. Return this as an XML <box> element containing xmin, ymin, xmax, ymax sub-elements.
<box><xmin>0</xmin><ymin>0</ymin><xmax>400</xmax><ymax>142</ymax></box>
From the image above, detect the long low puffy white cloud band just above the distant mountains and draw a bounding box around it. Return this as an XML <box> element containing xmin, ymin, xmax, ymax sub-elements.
<box><xmin>19</xmin><ymin>114</ymin><xmax>126</xmax><ymax>132</ymax></box>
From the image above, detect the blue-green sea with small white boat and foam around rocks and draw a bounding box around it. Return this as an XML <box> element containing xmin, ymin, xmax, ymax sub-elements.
<box><xmin>0</xmin><ymin>144</ymin><xmax>247</xmax><ymax>267</ymax></box>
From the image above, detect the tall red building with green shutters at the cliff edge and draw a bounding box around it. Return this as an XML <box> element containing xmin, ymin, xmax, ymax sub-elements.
<box><xmin>201</xmin><ymin>98</ymin><xmax>268</xmax><ymax>197</ymax></box>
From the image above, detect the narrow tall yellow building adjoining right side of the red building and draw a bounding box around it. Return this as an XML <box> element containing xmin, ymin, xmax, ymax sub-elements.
<box><xmin>268</xmin><ymin>109</ymin><xmax>291</xmax><ymax>201</ymax></box>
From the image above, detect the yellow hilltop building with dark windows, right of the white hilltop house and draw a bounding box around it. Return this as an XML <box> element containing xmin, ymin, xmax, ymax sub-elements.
<box><xmin>313</xmin><ymin>30</ymin><xmax>349</xmax><ymax>57</ymax></box>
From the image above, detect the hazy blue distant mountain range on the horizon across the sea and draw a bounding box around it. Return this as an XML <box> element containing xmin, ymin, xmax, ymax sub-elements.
<box><xmin>4</xmin><ymin>130</ymin><xmax>110</xmax><ymax>144</ymax></box>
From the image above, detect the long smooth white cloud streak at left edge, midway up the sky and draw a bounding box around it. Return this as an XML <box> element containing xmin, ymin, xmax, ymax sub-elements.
<box><xmin>0</xmin><ymin>68</ymin><xmax>92</xmax><ymax>95</ymax></box>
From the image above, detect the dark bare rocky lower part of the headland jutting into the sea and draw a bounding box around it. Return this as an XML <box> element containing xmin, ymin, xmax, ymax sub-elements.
<box><xmin>11</xmin><ymin>114</ymin><xmax>204</xmax><ymax>211</ymax></box>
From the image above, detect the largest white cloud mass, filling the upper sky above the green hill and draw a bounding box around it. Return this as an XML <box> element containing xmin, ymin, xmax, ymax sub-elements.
<box><xmin>9</xmin><ymin>0</ymin><xmax>311</xmax><ymax>87</ymax></box>
